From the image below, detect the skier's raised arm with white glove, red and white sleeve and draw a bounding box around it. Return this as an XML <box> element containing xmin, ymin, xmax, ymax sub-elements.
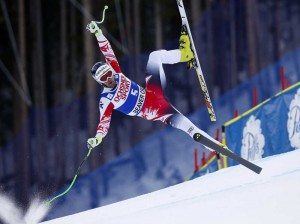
<box><xmin>87</xmin><ymin>21</ymin><xmax>122</xmax><ymax>73</ymax></box>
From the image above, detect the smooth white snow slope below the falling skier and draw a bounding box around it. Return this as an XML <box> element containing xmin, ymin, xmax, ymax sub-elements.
<box><xmin>44</xmin><ymin>150</ymin><xmax>300</xmax><ymax>224</ymax></box>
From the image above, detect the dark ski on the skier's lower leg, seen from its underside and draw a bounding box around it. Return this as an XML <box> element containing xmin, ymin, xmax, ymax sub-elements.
<box><xmin>193</xmin><ymin>133</ymin><xmax>262</xmax><ymax>174</ymax></box>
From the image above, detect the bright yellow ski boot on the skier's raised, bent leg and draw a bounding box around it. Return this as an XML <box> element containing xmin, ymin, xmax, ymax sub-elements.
<box><xmin>179</xmin><ymin>26</ymin><xmax>194</xmax><ymax>68</ymax></box>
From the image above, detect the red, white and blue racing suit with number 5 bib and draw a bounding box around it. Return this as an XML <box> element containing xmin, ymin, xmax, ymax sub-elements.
<box><xmin>97</xmin><ymin>32</ymin><xmax>215</xmax><ymax>147</ymax></box>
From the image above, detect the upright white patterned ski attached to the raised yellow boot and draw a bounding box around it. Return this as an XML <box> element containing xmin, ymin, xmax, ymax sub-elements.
<box><xmin>176</xmin><ymin>0</ymin><xmax>217</xmax><ymax>121</ymax></box>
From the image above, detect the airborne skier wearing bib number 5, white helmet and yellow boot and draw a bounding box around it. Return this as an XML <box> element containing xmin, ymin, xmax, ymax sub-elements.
<box><xmin>87</xmin><ymin>21</ymin><xmax>227</xmax><ymax>150</ymax></box>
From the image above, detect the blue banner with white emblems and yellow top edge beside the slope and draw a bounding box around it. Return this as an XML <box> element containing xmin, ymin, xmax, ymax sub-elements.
<box><xmin>224</xmin><ymin>83</ymin><xmax>300</xmax><ymax>165</ymax></box>
